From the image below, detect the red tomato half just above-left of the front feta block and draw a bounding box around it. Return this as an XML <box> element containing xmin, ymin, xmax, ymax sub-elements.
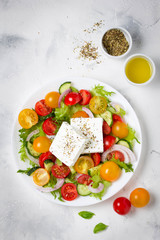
<box><xmin>42</xmin><ymin>118</ymin><xmax>57</xmax><ymax>135</ymax></box>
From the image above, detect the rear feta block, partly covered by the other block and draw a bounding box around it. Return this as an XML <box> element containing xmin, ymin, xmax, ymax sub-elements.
<box><xmin>71</xmin><ymin>118</ymin><xmax>103</xmax><ymax>153</ymax></box>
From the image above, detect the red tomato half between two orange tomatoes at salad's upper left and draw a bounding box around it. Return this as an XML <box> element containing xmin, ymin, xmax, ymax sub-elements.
<box><xmin>35</xmin><ymin>99</ymin><xmax>52</xmax><ymax>116</ymax></box>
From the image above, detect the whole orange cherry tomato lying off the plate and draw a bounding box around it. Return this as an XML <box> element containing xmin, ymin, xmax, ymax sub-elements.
<box><xmin>130</xmin><ymin>188</ymin><xmax>150</xmax><ymax>208</ymax></box>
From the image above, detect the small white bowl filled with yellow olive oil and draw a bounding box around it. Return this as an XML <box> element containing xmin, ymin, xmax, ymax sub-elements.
<box><xmin>124</xmin><ymin>54</ymin><xmax>156</xmax><ymax>86</ymax></box>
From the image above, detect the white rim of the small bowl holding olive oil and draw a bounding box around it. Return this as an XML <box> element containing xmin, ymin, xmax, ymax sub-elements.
<box><xmin>124</xmin><ymin>53</ymin><xmax>156</xmax><ymax>86</ymax></box>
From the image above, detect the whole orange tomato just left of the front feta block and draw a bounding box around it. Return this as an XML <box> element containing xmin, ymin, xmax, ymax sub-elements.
<box><xmin>33</xmin><ymin>136</ymin><xmax>52</xmax><ymax>153</ymax></box>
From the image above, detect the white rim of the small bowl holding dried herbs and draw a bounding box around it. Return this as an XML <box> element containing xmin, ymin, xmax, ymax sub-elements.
<box><xmin>100</xmin><ymin>27</ymin><xmax>132</xmax><ymax>59</ymax></box>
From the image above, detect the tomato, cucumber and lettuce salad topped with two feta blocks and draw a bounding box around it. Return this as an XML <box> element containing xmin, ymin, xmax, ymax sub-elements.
<box><xmin>18</xmin><ymin>82</ymin><xmax>139</xmax><ymax>201</ymax></box>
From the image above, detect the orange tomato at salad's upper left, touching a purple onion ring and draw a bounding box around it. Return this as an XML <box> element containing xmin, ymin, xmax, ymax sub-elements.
<box><xmin>45</xmin><ymin>92</ymin><xmax>60</xmax><ymax>108</ymax></box>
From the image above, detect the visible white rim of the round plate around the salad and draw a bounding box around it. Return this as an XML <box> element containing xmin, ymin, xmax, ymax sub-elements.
<box><xmin>13</xmin><ymin>77</ymin><xmax>142</xmax><ymax>206</ymax></box>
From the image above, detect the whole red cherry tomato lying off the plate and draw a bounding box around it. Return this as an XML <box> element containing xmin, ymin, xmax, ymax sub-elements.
<box><xmin>113</xmin><ymin>197</ymin><xmax>131</xmax><ymax>215</ymax></box>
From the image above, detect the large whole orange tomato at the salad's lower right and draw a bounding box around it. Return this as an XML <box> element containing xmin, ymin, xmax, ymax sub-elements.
<box><xmin>100</xmin><ymin>161</ymin><xmax>121</xmax><ymax>182</ymax></box>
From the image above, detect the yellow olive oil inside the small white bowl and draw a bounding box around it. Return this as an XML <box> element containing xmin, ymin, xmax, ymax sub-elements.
<box><xmin>125</xmin><ymin>57</ymin><xmax>152</xmax><ymax>83</ymax></box>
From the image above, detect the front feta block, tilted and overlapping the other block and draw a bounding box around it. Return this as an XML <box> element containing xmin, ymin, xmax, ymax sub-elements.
<box><xmin>49</xmin><ymin>122</ymin><xmax>86</xmax><ymax>166</ymax></box>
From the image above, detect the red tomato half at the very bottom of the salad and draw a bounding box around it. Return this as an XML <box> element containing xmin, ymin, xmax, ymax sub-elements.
<box><xmin>61</xmin><ymin>183</ymin><xmax>78</xmax><ymax>201</ymax></box>
